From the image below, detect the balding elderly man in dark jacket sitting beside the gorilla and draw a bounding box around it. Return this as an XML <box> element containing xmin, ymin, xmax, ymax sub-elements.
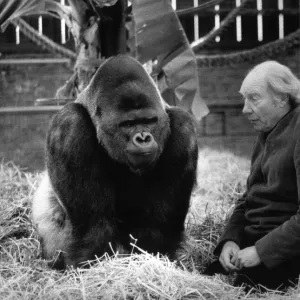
<box><xmin>205</xmin><ymin>61</ymin><xmax>300</xmax><ymax>289</ymax></box>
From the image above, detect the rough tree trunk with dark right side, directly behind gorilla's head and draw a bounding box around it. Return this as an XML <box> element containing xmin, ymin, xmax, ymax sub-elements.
<box><xmin>55</xmin><ymin>0</ymin><xmax>127</xmax><ymax>99</ymax></box>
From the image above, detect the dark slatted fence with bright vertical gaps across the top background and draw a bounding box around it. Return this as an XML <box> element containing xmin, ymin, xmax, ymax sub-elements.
<box><xmin>0</xmin><ymin>0</ymin><xmax>299</xmax><ymax>54</ymax></box>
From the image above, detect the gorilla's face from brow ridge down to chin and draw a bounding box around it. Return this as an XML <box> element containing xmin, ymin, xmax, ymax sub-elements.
<box><xmin>96</xmin><ymin>98</ymin><xmax>170</xmax><ymax>174</ymax></box>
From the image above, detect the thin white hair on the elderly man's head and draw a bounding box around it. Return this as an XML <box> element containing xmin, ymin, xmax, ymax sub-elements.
<box><xmin>249</xmin><ymin>60</ymin><xmax>300</xmax><ymax>105</ymax></box>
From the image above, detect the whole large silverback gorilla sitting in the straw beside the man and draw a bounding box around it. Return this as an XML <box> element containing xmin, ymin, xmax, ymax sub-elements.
<box><xmin>32</xmin><ymin>55</ymin><xmax>198</xmax><ymax>269</ymax></box>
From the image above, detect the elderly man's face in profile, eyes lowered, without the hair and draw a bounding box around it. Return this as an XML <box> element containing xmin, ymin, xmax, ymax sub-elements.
<box><xmin>240</xmin><ymin>72</ymin><xmax>284</xmax><ymax>132</ymax></box>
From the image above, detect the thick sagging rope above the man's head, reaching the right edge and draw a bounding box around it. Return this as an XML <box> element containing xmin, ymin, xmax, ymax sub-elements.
<box><xmin>197</xmin><ymin>29</ymin><xmax>300</xmax><ymax>67</ymax></box>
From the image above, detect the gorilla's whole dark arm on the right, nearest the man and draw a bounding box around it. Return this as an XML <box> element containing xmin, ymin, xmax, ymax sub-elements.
<box><xmin>132</xmin><ymin>108</ymin><xmax>198</xmax><ymax>255</ymax></box>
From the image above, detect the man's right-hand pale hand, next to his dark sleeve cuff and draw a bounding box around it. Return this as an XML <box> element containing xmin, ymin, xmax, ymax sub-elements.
<box><xmin>231</xmin><ymin>246</ymin><xmax>261</xmax><ymax>269</ymax></box>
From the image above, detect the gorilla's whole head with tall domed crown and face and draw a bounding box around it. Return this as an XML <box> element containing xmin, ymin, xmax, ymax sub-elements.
<box><xmin>77</xmin><ymin>55</ymin><xmax>170</xmax><ymax>174</ymax></box>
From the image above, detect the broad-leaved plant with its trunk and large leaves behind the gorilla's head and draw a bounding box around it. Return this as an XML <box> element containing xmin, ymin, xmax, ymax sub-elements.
<box><xmin>0</xmin><ymin>0</ymin><xmax>210</xmax><ymax>119</ymax></box>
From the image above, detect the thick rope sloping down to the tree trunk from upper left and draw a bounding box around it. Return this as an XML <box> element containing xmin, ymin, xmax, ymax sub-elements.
<box><xmin>11</xmin><ymin>18</ymin><xmax>76</xmax><ymax>59</ymax></box>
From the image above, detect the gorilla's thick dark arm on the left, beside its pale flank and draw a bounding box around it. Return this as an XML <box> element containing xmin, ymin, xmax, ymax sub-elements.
<box><xmin>46</xmin><ymin>103</ymin><xmax>116</xmax><ymax>260</ymax></box>
